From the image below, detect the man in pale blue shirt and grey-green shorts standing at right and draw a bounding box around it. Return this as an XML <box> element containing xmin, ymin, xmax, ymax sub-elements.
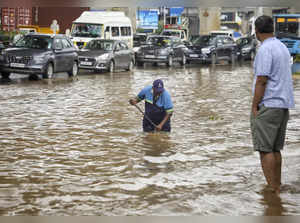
<box><xmin>251</xmin><ymin>15</ymin><xmax>295</xmax><ymax>194</ymax></box>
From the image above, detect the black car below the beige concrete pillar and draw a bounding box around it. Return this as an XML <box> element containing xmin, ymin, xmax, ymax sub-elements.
<box><xmin>186</xmin><ymin>35</ymin><xmax>237</xmax><ymax>63</ymax></box>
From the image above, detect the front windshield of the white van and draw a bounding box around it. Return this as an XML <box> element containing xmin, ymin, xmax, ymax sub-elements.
<box><xmin>71</xmin><ymin>23</ymin><xmax>103</xmax><ymax>38</ymax></box>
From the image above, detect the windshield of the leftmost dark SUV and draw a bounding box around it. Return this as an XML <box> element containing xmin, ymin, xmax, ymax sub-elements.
<box><xmin>15</xmin><ymin>36</ymin><xmax>53</xmax><ymax>50</ymax></box>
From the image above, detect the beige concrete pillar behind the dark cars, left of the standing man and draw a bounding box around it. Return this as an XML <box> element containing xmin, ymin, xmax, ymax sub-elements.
<box><xmin>199</xmin><ymin>7</ymin><xmax>221</xmax><ymax>35</ymax></box>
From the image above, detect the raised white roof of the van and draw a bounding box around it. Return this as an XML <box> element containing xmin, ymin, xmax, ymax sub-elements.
<box><xmin>74</xmin><ymin>11</ymin><xmax>131</xmax><ymax>25</ymax></box>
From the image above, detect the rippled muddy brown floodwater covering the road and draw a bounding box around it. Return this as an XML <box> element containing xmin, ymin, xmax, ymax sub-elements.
<box><xmin>0</xmin><ymin>63</ymin><xmax>300</xmax><ymax>216</ymax></box>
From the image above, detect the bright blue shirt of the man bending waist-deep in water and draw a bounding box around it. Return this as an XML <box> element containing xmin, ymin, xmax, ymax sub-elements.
<box><xmin>138</xmin><ymin>85</ymin><xmax>173</xmax><ymax>113</ymax></box>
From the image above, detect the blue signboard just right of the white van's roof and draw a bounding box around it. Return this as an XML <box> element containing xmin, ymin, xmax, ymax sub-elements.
<box><xmin>137</xmin><ymin>10</ymin><xmax>158</xmax><ymax>29</ymax></box>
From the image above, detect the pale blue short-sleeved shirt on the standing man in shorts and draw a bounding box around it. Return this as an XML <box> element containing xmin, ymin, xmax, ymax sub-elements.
<box><xmin>253</xmin><ymin>37</ymin><xmax>295</xmax><ymax>108</ymax></box>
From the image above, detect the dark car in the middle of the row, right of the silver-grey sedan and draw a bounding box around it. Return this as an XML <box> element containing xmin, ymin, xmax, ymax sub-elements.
<box><xmin>136</xmin><ymin>35</ymin><xmax>187</xmax><ymax>66</ymax></box>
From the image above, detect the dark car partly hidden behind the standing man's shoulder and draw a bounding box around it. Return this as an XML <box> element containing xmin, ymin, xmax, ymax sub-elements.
<box><xmin>236</xmin><ymin>36</ymin><xmax>258</xmax><ymax>60</ymax></box>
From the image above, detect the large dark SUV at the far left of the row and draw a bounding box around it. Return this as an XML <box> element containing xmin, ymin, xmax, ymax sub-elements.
<box><xmin>0</xmin><ymin>34</ymin><xmax>78</xmax><ymax>78</ymax></box>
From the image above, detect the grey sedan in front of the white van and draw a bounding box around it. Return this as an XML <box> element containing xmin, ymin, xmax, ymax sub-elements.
<box><xmin>78</xmin><ymin>39</ymin><xmax>134</xmax><ymax>72</ymax></box>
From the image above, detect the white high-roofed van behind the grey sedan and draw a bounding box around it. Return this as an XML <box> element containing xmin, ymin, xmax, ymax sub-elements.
<box><xmin>70</xmin><ymin>11</ymin><xmax>133</xmax><ymax>48</ymax></box>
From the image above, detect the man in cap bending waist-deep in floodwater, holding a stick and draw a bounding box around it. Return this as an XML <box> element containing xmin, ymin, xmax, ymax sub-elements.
<box><xmin>129</xmin><ymin>79</ymin><xmax>173</xmax><ymax>132</ymax></box>
